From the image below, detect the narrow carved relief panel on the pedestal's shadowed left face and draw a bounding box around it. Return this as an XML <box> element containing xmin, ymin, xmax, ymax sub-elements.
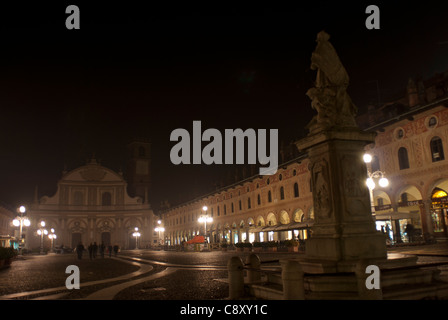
<box><xmin>312</xmin><ymin>159</ymin><xmax>332</xmax><ymax>218</ymax></box>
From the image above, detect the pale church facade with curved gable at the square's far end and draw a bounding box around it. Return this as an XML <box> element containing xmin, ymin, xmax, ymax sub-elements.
<box><xmin>26</xmin><ymin>159</ymin><xmax>158</xmax><ymax>249</ymax></box>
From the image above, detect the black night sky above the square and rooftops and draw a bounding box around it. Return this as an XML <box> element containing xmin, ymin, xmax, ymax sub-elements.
<box><xmin>0</xmin><ymin>1</ymin><xmax>448</xmax><ymax>207</ymax></box>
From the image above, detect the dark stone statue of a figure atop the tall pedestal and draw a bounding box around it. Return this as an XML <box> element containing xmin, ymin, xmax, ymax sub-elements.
<box><xmin>306</xmin><ymin>31</ymin><xmax>357</xmax><ymax>131</ymax></box>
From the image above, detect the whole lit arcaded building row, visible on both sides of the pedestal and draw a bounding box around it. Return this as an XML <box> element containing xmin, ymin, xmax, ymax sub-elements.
<box><xmin>163</xmin><ymin>72</ymin><xmax>448</xmax><ymax>245</ymax></box>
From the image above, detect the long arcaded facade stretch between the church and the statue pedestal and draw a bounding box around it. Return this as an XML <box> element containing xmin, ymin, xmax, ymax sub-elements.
<box><xmin>163</xmin><ymin>157</ymin><xmax>314</xmax><ymax>245</ymax></box>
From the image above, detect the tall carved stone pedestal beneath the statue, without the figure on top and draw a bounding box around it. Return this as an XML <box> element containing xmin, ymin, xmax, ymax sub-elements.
<box><xmin>296</xmin><ymin>127</ymin><xmax>387</xmax><ymax>261</ymax></box>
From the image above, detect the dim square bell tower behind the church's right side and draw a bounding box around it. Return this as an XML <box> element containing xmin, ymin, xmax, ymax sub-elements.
<box><xmin>127</xmin><ymin>139</ymin><xmax>151</xmax><ymax>203</ymax></box>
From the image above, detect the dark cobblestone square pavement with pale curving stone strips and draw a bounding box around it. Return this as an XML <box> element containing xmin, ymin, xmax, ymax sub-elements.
<box><xmin>0</xmin><ymin>243</ymin><xmax>448</xmax><ymax>300</ymax></box>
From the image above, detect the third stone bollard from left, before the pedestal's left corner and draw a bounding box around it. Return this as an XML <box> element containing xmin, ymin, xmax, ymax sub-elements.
<box><xmin>280</xmin><ymin>260</ymin><xmax>305</xmax><ymax>300</ymax></box>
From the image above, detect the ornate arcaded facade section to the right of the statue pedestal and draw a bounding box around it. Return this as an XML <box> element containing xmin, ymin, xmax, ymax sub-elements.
<box><xmin>359</xmin><ymin>73</ymin><xmax>448</xmax><ymax>242</ymax></box>
